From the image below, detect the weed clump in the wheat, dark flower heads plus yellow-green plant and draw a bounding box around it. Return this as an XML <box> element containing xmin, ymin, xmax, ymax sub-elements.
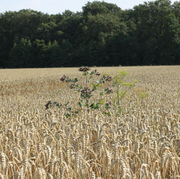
<box><xmin>47</xmin><ymin>67</ymin><xmax>135</xmax><ymax>117</ymax></box>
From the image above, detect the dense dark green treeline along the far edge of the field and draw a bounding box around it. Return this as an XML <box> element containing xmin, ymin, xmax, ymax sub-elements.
<box><xmin>0</xmin><ymin>0</ymin><xmax>180</xmax><ymax>68</ymax></box>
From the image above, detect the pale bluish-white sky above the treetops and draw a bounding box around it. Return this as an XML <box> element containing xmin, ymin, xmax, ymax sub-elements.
<box><xmin>0</xmin><ymin>0</ymin><xmax>175</xmax><ymax>14</ymax></box>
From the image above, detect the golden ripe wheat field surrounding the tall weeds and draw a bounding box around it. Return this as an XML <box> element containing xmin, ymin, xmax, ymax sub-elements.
<box><xmin>0</xmin><ymin>66</ymin><xmax>180</xmax><ymax>179</ymax></box>
